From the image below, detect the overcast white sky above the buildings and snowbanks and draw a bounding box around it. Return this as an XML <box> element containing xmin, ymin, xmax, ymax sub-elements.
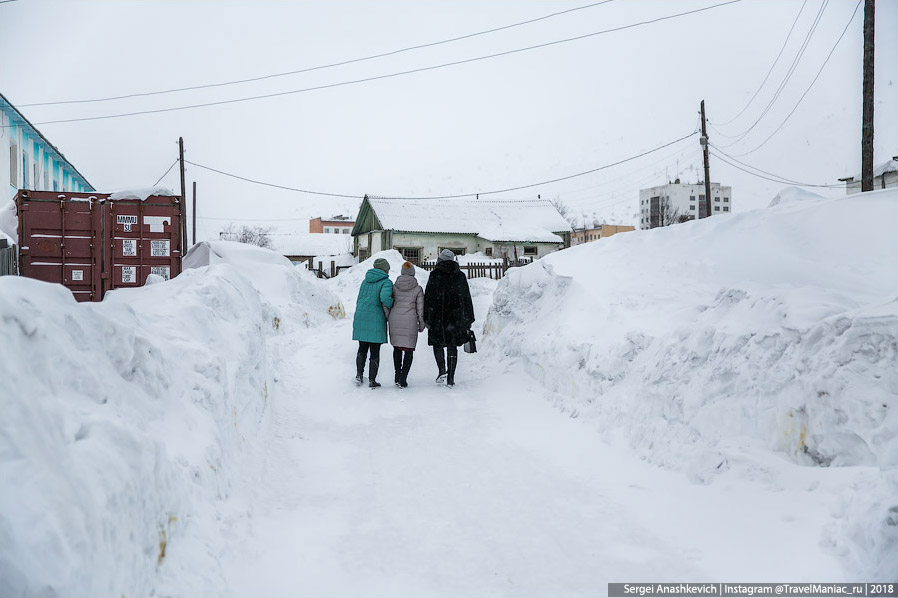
<box><xmin>0</xmin><ymin>0</ymin><xmax>898</xmax><ymax>239</ymax></box>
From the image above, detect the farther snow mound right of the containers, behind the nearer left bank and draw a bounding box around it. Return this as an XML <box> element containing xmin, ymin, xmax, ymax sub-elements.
<box><xmin>184</xmin><ymin>241</ymin><xmax>344</xmax><ymax>326</ymax></box>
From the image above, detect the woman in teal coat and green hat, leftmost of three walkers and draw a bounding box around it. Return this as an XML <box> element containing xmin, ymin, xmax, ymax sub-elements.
<box><xmin>352</xmin><ymin>258</ymin><xmax>393</xmax><ymax>388</ymax></box>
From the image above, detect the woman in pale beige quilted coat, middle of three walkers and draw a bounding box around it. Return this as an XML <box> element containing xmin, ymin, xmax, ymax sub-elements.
<box><xmin>388</xmin><ymin>262</ymin><xmax>424</xmax><ymax>388</ymax></box>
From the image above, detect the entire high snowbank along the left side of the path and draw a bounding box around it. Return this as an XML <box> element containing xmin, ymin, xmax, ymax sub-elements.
<box><xmin>0</xmin><ymin>243</ymin><xmax>342</xmax><ymax>596</ymax></box>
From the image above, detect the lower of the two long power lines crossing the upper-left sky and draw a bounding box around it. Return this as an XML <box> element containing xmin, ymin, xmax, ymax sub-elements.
<box><xmin>14</xmin><ymin>0</ymin><xmax>742</xmax><ymax>125</ymax></box>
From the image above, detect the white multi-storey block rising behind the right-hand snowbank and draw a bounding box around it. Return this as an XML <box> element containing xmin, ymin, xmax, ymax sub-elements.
<box><xmin>639</xmin><ymin>182</ymin><xmax>733</xmax><ymax>229</ymax></box>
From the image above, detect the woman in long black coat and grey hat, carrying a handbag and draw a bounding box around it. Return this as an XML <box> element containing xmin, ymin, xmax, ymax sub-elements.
<box><xmin>424</xmin><ymin>249</ymin><xmax>474</xmax><ymax>386</ymax></box>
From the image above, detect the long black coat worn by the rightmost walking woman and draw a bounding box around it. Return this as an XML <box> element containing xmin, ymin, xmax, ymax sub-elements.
<box><xmin>424</xmin><ymin>260</ymin><xmax>474</xmax><ymax>347</ymax></box>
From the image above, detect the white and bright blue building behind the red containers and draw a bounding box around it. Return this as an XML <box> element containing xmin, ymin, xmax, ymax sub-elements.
<box><xmin>0</xmin><ymin>94</ymin><xmax>96</xmax><ymax>203</ymax></box>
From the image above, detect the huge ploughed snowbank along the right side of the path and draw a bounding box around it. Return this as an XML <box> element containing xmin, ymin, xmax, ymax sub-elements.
<box><xmin>485</xmin><ymin>190</ymin><xmax>898</xmax><ymax>578</ymax></box>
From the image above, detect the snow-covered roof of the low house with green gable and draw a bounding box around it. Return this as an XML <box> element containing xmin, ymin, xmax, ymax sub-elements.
<box><xmin>360</xmin><ymin>197</ymin><xmax>571</xmax><ymax>243</ymax></box>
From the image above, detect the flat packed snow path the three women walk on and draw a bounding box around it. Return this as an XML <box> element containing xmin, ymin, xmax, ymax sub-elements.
<box><xmin>223</xmin><ymin>315</ymin><xmax>845</xmax><ymax>596</ymax></box>
